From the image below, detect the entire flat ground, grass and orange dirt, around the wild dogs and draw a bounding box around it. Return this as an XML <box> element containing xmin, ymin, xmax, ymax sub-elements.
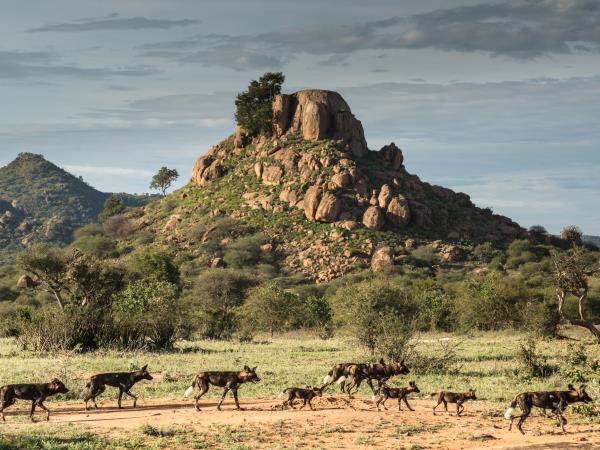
<box><xmin>0</xmin><ymin>329</ymin><xmax>600</xmax><ymax>449</ymax></box>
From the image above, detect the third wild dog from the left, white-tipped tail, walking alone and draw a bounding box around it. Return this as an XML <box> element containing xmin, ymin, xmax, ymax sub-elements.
<box><xmin>185</xmin><ymin>366</ymin><xmax>260</xmax><ymax>411</ymax></box>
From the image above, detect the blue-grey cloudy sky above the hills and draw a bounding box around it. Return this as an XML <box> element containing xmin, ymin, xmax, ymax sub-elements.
<box><xmin>0</xmin><ymin>0</ymin><xmax>600</xmax><ymax>235</ymax></box>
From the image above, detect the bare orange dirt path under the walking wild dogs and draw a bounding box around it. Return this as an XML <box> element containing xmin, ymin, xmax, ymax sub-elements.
<box><xmin>0</xmin><ymin>396</ymin><xmax>600</xmax><ymax>449</ymax></box>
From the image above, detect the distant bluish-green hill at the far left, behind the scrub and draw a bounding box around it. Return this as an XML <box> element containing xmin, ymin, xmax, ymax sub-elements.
<box><xmin>0</xmin><ymin>153</ymin><xmax>155</xmax><ymax>262</ymax></box>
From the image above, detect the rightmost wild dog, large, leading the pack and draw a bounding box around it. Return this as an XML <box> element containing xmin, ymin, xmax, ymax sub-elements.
<box><xmin>504</xmin><ymin>384</ymin><xmax>593</xmax><ymax>434</ymax></box>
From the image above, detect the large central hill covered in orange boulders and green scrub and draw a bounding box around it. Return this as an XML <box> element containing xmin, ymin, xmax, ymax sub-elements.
<box><xmin>122</xmin><ymin>90</ymin><xmax>526</xmax><ymax>281</ymax></box>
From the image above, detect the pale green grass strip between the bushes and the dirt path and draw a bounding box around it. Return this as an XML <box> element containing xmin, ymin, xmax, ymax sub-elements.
<box><xmin>0</xmin><ymin>330</ymin><xmax>600</xmax><ymax>402</ymax></box>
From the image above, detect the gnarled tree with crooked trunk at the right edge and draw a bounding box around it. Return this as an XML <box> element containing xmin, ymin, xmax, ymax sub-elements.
<box><xmin>553</xmin><ymin>247</ymin><xmax>600</xmax><ymax>343</ymax></box>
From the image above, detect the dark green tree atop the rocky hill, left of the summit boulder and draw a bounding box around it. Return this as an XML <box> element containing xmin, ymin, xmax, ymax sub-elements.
<box><xmin>235</xmin><ymin>72</ymin><xmax>285</xmax><ymax>136</ymax></box>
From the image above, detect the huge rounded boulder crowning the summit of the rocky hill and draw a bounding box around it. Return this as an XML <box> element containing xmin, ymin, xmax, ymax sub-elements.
<box><xmin>273</xmin><ymin>89</ymin><xmax>368</xmax><ymax>156</ymax></box>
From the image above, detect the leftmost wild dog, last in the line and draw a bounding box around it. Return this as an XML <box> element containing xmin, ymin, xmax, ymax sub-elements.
<box><xmin>0</xmin><ymin>378</ymin><xmax>69</xmax><ymax>422</ymax></box>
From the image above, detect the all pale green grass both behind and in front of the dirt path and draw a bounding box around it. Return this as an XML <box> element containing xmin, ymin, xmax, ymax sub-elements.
<box><xmin>0</xmin><ymin>329</ymin><xmax>600</xmax><ymax>450</ymax></box>
